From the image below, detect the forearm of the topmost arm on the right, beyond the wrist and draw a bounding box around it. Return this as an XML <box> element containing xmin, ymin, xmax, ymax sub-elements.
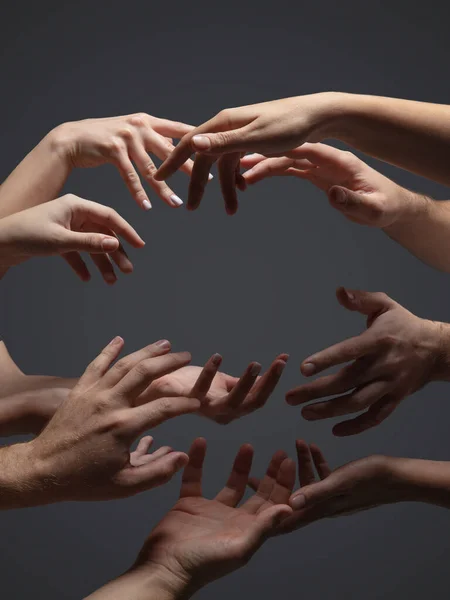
<box><xmin>324</xmin><ymin>93</ymin><xmax>450</xmax><ymax>185</ymax></box>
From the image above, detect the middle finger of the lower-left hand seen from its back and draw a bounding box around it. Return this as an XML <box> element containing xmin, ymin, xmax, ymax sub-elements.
<box><xmin>115</xmin><ymin>352</ymin><xmax>192</xmax><ymax>401</ymax></box>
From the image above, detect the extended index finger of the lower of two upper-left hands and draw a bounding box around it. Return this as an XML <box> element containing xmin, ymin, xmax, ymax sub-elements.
<box><xmin>74</xmin><ymin>200</ymin><xmax>145</xmax><ymax>251</ymax></box>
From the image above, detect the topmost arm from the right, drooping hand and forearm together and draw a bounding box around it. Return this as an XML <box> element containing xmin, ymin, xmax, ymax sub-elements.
<box><xmin>156</xmin><ymin>92</ymin><xmax>450</xmax><ymax>214</ymax></box>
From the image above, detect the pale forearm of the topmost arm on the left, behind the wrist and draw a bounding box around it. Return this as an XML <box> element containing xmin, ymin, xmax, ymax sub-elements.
<box><xmin>0</xmin><ymin>127</ymin><xmax>71</xmax><ymax>218</ymax></box>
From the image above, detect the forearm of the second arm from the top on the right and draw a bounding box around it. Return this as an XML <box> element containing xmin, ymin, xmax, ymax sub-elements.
<box><xmin>384</xmin><ymin>196</ymin><xmax>450</xmax><ymax>272</ymax></box>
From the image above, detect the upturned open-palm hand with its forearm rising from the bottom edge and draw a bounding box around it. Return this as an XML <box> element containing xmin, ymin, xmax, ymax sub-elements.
<box><xmin>85</xmin><ymin>438</ymin><xmax>295</xmax><ymax>600</ymax></box>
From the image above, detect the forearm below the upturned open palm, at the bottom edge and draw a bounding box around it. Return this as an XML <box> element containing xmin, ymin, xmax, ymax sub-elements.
<box><xmin>85</xmin><ymin>569</ymin><xmax>192</xmax><ymax>600</ymax></box>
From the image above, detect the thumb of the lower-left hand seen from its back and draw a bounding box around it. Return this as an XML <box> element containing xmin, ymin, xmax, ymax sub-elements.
<box><xmin>117</xmin><ymin>452</ymin><xmax>189</xmax><ymax>495</ymax></box>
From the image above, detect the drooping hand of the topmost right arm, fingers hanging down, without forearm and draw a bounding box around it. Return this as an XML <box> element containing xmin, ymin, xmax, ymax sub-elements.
<box><xmin>155</xmin><ymin>93</ymin><xmax>338</xmax><ymax>214</ymax></box>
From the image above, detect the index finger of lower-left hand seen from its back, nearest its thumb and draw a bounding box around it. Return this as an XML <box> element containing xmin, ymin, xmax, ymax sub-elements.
<box><xmin>121</xmin><ymin>396</ymin><xmax>200</xmax><ymax>440</ymax></box>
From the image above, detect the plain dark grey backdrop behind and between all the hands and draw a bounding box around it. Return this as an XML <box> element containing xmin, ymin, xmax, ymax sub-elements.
<box><xmin>0</xmin><ymin>0</ymin><xmax>450</xmax><ymax>600</ymax></box>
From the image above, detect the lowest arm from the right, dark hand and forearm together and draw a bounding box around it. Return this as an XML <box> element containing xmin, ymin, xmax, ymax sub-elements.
<box><xmin>268</xmin><ymin>440</ymin><xmax>450</xmax><ymax>533</ymax></box>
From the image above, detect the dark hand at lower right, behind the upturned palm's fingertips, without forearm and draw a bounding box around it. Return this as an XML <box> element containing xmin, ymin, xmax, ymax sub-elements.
<box><xmin>284</xmin><ymin>440</ymin><xmax>402</xmax><ymax>533</ymax></box>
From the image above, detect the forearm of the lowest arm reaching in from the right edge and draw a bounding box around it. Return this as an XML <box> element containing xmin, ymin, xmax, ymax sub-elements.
<box><xmin>391</xmin><ymin>458</ymin><xmax>450</xmax><ymax>508</ymax></box>
